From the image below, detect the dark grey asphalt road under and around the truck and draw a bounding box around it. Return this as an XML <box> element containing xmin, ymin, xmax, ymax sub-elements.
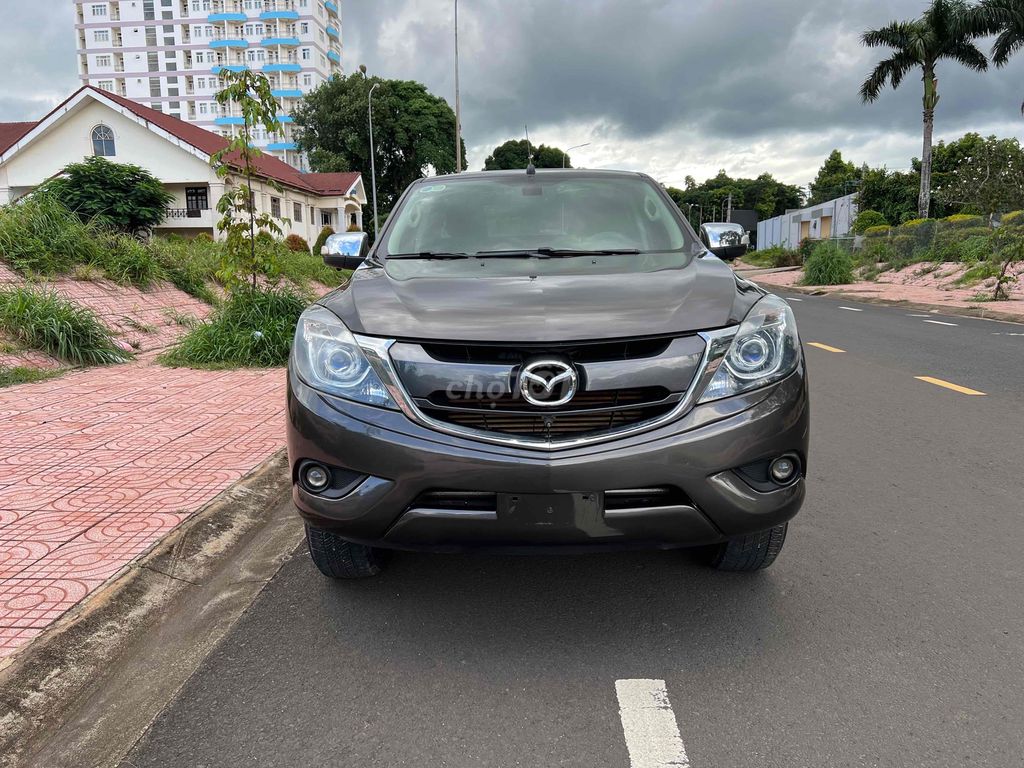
<box><xmin>123</xmin><ymin>296</ymin><xmax>1024</xmax><ymax>768</ymax></box>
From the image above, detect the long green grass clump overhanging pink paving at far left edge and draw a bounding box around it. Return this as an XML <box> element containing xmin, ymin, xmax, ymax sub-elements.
<box><xmin>0</xmin><ymin>287</ymin><xmax>131</xmax><ymax>366</ymax></box>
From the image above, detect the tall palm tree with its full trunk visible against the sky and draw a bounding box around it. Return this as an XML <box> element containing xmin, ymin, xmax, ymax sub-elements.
<box><xmin>860</xmin><ymin>0</ymin><xmax>988</xmax><ymax>218</ymax></box>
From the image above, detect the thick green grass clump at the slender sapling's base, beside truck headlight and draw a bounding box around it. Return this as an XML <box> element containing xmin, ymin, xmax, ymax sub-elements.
<box><xmin>161</xmin><ymin>287</ymin><xmax>306</xmax><ymax>368</ymax></box>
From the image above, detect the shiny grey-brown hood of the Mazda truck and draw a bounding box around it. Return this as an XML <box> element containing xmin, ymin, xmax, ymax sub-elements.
<box><xmin>319</xmin><ymin>256</ymin><xmax>763</xmax><ymax>343</ymax></box>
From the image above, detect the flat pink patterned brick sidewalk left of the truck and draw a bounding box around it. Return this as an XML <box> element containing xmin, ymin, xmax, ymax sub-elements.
<box><xmin>0</xmin><ymin>361</ymin><xmax>285</xmax><ymax>657</ymax></box>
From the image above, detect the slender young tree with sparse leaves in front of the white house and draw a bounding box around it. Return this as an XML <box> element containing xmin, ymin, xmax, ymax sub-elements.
<box><xmin>210</xmin><ymin>70</ymin><xmax>287</xmax><ymax>290</ymax></box>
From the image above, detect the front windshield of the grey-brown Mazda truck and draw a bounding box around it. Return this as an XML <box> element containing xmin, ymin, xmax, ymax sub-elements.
<box><xmin>380</xmin><ymin>173</ymin><xmax>692</xmax><ymax>256</ymax></box>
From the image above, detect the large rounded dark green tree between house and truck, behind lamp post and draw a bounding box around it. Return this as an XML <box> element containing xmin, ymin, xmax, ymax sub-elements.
<box><xmin>293</xmin><ymin>73</ymin><xmax>466</xmax><ymax>215</ymax></box>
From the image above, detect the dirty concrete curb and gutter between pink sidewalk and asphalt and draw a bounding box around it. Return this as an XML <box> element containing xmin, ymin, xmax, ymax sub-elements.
<box><xmin>0</xmin><ymin>450</ymin><xmax>302</xmax><ymax>768</ymax></box>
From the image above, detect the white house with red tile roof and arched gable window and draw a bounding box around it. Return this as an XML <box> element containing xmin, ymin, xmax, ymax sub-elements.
<box><xmin>0</xmin><ymin>86</ymin><xmax>367</xmax><ymax>243</ymax></box>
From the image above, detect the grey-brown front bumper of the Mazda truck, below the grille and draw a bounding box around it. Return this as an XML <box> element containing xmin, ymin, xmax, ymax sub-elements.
<box><xmin>288</xmin><ymin>364</ymin><xmax>808</xmax><ymax>551</ymax></box>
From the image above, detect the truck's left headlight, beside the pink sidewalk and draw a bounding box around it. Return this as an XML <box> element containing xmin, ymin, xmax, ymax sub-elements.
<box><xmin>295</xmin><ymin>306</ymin><xmax>398</xmax><ymax>410</ymax></box>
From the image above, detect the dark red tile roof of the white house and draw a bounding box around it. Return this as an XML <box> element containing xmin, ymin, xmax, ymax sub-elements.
<box><xmin>0</xmin><ymin>85</ymin><xmax>359</xmax><ymax>195</ymax></box>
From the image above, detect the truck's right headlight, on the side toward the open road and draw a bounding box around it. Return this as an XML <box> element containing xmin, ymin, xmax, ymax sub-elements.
<box><xmin>700</xmin><ymin>296</ymin><xmax>800</xmax><ymax>402</ymax></box>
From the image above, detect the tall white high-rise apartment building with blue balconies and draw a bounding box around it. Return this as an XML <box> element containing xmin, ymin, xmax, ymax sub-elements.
<box><xmin>74</xmin><ymin>0</ymin><xmax>341</xmax><ymax>168</ymax></box>
